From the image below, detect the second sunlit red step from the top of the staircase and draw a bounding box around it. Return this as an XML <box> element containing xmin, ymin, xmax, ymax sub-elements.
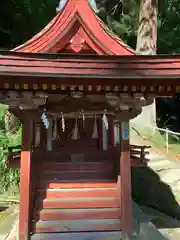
<box><xmin>36</xmin><ymin>188</ymin><xmax>120</xmax><ymax>199</ymax></box>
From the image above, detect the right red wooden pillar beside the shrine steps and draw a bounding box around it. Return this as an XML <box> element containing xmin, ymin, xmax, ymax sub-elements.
<box><xmin>120</xmin><ymin>121</ymin><xmax>132</xmax><ymax>233</ymax></box>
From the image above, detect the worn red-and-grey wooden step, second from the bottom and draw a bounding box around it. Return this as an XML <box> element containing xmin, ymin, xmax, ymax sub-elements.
<box><xmin>33</xmin><ymin>219</ymin><xmax>120</xmax><ymax>233</ymax></box>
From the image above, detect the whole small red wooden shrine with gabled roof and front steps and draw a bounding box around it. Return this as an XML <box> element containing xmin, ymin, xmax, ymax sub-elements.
<box><xmin>0</xmin><ymin>0</ymin><xmax>180</xmax><ymax>240</ymax></box>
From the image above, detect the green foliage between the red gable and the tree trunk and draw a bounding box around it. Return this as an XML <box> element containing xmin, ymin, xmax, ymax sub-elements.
<box><xmin>96</xmin><ymin>0</ymin><xmax>139</xmax><ymax>49</ymax></box>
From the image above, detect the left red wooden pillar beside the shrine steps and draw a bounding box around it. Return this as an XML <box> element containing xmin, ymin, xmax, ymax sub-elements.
<box><xmin>19</xmin><ymin>111</ymin><xmax>33</xmax><ymax>240</ymax></box>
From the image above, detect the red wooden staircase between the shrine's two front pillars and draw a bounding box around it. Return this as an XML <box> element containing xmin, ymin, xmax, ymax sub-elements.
<box><xmin>31</xmin><ymin>161</ymin><xmax>121</xmax><ymax>240</ymax></box>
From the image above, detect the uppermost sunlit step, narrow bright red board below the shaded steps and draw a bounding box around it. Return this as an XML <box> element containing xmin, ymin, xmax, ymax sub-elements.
<box><xmin>37</xmin><ymin>178</ymin><xmax>117</xmax><ymax>189</ymax></box>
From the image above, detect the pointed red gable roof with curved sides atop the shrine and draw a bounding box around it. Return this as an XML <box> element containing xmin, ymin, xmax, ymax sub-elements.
<box><xmin>12</xmin><ymin>0</ymin><xmax>135</xmax><ymax>55</ymax></box>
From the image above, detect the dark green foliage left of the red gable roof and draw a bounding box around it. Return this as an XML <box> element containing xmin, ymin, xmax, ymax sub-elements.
<box><xmin>0</xmin><ymin>0</ymin><xmax>59</xmax><ymax>49</ymax></box>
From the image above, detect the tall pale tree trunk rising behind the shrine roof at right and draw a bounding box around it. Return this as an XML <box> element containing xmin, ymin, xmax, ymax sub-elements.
<box><xmin>133</xmin><ymin>0</ymin><xmax>158</xmax><ymax>126</ymax></box>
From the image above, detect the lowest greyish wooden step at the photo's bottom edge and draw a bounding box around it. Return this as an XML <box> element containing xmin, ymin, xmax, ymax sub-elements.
<box><xmin>31</xmin><ymin>231</ymin><xmax>121</xmax><ymax>240</ymax></box>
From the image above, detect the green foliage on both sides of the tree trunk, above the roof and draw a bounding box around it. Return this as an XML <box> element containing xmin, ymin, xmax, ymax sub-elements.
<box><xmin>96</xmin><ymin>0</ymin><xmax>180</xmax><ymax>54</ymax></box>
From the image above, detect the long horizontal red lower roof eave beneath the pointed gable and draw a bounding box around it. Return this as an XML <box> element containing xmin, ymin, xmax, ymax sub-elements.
<box><xmin>0</xmin><ymin>51</ymin><xmax>180</xmax><ymax>79</ymax></box>
